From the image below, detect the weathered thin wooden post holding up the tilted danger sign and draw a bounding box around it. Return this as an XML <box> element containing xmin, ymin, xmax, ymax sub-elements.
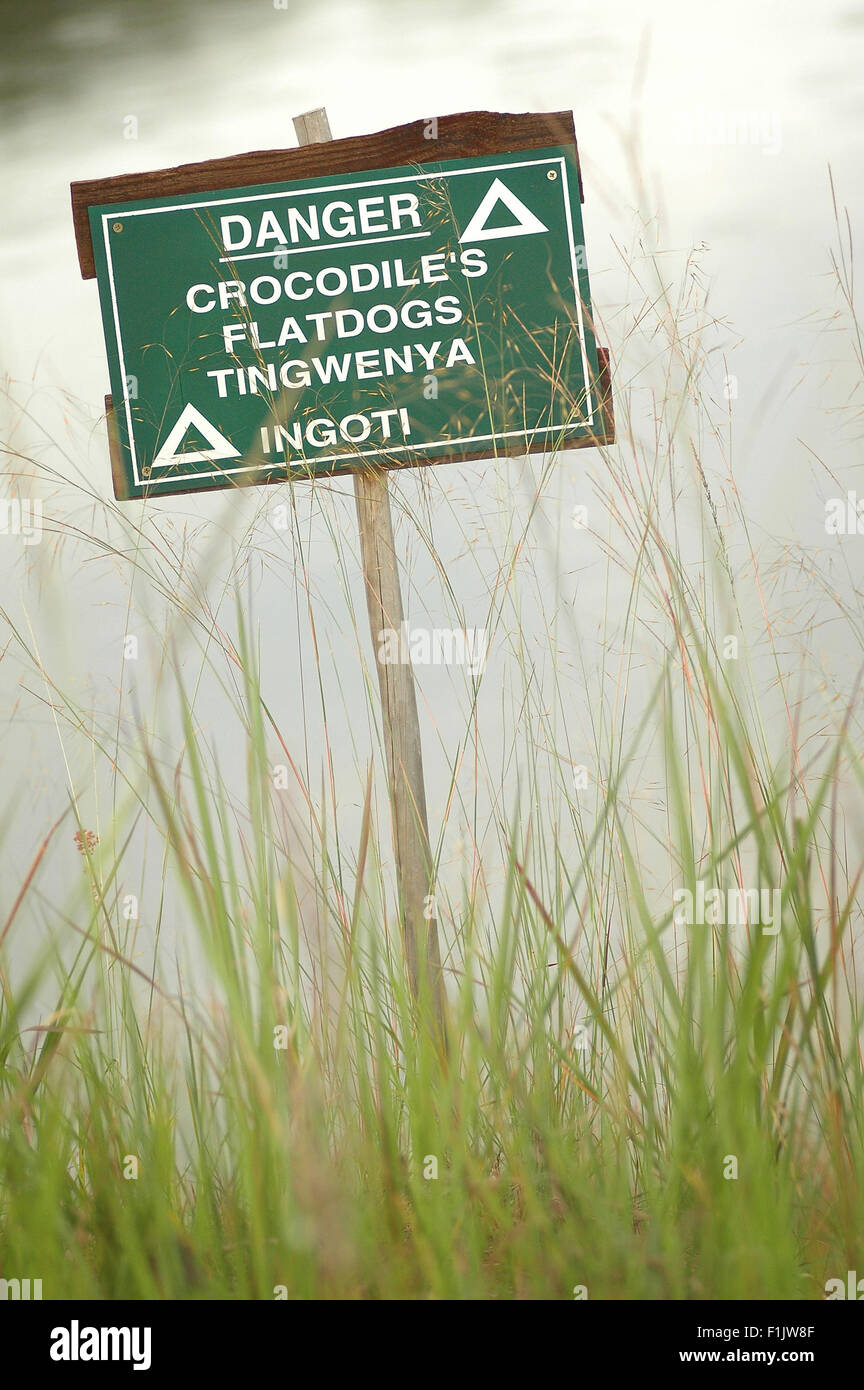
<box><xmin>294</xmin><ymin>107</ymin><xmax>445</xmax><ymax>1037</ymax></box>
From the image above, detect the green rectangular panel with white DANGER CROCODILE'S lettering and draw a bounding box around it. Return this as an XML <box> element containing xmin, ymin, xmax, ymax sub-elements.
<box><xmin>82</xmin><ymin>146</ymin><xmax>606</xmax><ymax>496</ymax></box>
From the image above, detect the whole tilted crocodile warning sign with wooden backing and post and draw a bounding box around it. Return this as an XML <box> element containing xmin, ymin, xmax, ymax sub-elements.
<box><xmin>72</xmin><ymin>111</ymin><xmax>614</xmax><ymax>1030</ymax></box>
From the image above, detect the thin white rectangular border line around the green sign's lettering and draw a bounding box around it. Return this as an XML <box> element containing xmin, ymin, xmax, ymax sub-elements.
<box><xmin>101</xmin><ymin>156</ymin><xmax>595</xmax><ymax>488</ymax></box>
